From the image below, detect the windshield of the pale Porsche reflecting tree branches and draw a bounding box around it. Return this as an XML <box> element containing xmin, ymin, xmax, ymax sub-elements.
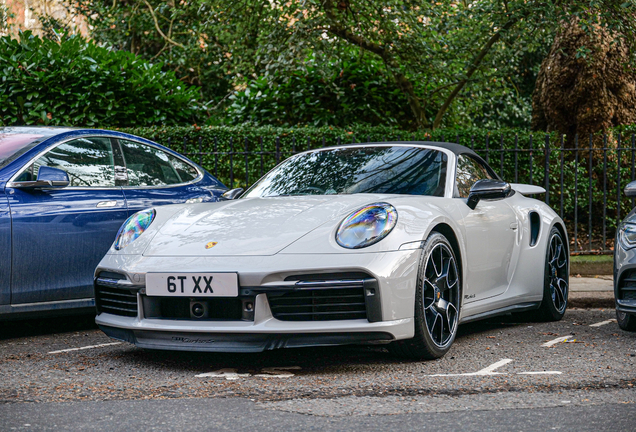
<box><xmin>244</xmin><ymin>146</ymin><xmax>447</xmax><ymax>197</ymax></box>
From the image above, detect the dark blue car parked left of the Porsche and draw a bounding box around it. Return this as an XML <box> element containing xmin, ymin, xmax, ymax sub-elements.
<box><xmin>0</xmin><ymin>127</ymin><xmax>227</xmax><ymax>320</ymax></box>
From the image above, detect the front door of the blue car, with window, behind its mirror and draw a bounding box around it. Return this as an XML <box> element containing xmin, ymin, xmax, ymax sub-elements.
<box><xmin>6</xmin><ymin>137</ymin><xmax>127</xmax><ymax>304</ymax></box>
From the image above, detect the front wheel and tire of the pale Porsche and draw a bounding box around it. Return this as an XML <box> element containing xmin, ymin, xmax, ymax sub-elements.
<box><xmin>389</xmin><ymin>232</ymin><xmax>462</xmax><ymax>360</ymax></box>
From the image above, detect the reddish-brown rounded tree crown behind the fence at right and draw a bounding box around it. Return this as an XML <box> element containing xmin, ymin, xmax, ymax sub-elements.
<box><xmin>532</xmin><ymin>16</ymin><xmax>636</xmax><ymax>141</ymax></box>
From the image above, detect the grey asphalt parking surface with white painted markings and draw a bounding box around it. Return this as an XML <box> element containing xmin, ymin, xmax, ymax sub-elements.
<box><xmin>0</xmin><ymin>309</ymin><xmax>636</xmax><ymax>431</ymax></box>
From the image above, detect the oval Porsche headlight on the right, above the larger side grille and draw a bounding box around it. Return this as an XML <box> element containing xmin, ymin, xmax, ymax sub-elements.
<box><xmin>336</xmin><ymin>203</ymin><xmax>397</xmax><ymax>249</ymax></box>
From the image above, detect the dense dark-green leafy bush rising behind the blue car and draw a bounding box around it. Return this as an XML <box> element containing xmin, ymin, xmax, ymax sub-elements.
<box><xmin>0</xmin><ymin>32</ymin><xmax>203</xmax><ymax>127</ymax></box>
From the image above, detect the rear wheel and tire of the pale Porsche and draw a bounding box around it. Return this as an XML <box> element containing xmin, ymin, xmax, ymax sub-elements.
<box><xmin>539</xmin><ymin>227</ymin><xmax>570</xmax><ymax>321</ymax></box>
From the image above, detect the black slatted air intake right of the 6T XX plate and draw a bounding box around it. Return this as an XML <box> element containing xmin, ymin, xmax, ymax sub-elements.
<box><xmin>267</xmin><ymin>280</ymin><xmax>367</xmax><ymax>321</ymax></box>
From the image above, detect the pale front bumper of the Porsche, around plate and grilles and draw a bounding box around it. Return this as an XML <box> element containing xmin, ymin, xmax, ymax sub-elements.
<box><xmin>96</xmin><ymin>250</ymin><xmax>419</xmax><ymax>352</ymax></box>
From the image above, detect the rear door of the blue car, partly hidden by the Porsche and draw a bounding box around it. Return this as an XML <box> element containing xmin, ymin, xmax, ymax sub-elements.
<box><xmin>119</xmin><ymin>139</ymin><xmax>216</xmax><ymax>215</ymax></box>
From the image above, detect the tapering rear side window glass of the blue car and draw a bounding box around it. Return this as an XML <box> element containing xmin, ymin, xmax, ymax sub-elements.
<box><xmin>119</xmin><ymin>140</ymin><xmax>198</xmax><ymax>186</ymax></box>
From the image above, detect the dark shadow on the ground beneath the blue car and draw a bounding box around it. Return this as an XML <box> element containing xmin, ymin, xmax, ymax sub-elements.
<box><xmin>0</xmin><ymin>314</ymin><xmax>97</xmax><ymax>340</ymax></box>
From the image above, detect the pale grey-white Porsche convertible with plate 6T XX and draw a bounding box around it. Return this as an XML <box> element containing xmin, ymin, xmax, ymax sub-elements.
<box><xmin>95</xmin><ymin>142</ymin><xmax>569</xmax><ymax>358</ymax></box>
